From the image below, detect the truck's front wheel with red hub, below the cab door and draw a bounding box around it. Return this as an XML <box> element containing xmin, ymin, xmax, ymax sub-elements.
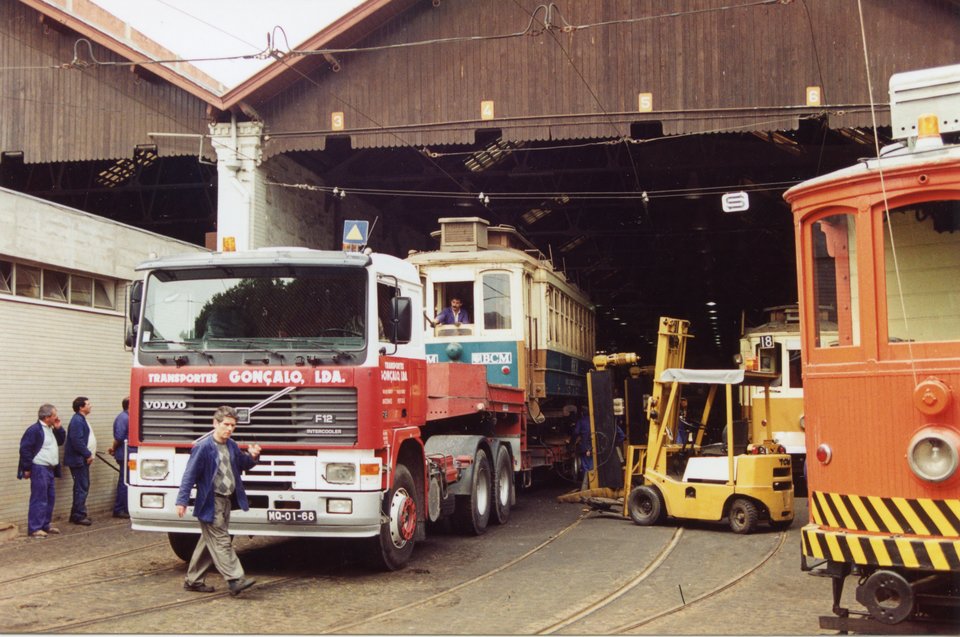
<box><xmin>369</xmin><ymin>464</ymin><xmax>417</xmax><ymax>571</ymax></box>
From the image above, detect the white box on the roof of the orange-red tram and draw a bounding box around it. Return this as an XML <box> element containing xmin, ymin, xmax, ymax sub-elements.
<box><xmin>890</xmin><ymin>64</ymin><xmax>960</xmax><ymax>139</ymax></box>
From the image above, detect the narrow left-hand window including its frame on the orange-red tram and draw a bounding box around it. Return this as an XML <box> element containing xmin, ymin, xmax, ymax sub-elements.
<box><xmin>804</xmin><ymin>208</ymin><xmax>865</xmax><ymax>353</ymax></box>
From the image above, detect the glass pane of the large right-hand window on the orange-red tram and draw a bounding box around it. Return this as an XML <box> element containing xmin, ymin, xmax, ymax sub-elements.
<box><xmin>883</xmin><ymin>201</ymin><xmax>960</xmax><ymax>343</ymax></box>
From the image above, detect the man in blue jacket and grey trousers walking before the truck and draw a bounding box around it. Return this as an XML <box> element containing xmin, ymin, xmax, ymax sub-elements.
<box><xmin>177</xmin><ymin>406</ymin><xmax>260</xmax><ymax>595</ymax></box>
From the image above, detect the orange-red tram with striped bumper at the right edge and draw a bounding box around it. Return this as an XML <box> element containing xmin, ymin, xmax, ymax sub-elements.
<box><xmin>784</xmin><ymin>65</ymin><xmax>960</xmax><ymax>634</ymax></box>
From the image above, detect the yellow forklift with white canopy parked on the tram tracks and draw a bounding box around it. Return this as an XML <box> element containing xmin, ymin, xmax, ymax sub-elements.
<box><xmin>624</xmin><ymin>317</ymin><xmax>794</xmax><ymax>533</ymax></box>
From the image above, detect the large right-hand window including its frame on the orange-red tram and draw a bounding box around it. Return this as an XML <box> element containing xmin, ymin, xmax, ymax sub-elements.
<box><xmin>875</xmin><ymin>197</ymin><xmax>960</xmax><ymax>348</ymax></box>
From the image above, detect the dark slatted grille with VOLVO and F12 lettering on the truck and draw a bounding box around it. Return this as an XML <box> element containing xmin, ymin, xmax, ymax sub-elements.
<box><xmin>140</xmin><ymin>387</ymin><xmax>357</xmax><ymax>445</ymax></box>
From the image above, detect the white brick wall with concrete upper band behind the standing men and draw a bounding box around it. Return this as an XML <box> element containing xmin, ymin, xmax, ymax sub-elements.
<box><xmin>0</xmin><ymin>189</ymin><xmax>203</xmax><ymax>533</ymax></box>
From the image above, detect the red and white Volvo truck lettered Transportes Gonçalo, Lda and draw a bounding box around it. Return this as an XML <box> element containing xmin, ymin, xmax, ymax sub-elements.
<box><xmin>126</xmin><ymin>242</ymin><xmax>569</xmax><ymax>569</ymax></box>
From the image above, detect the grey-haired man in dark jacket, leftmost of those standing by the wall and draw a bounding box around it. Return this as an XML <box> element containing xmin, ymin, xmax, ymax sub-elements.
<box><xmin>17</xmin><ymin>403</ymin><xmax>67</xmax><ymax>540</ymax></box>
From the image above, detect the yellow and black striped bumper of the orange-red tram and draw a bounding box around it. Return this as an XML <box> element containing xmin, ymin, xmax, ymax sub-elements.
<box><xmin>801</xmin><ymin>492</ymin><xmax>960</xmax><ymax>572</ymax></box>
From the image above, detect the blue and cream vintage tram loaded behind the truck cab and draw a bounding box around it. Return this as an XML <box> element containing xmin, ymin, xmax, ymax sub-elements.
<box><xmin>407</xmin><ymin>217</ymin><xmax>596</xmax><ymax>483</ymax></box>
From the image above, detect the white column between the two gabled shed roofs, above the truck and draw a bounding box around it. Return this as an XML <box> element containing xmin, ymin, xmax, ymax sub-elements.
<box><xmin>210</xmin><ymin>120</ymin><xmax>263</xmax><ymax>250</ymax></box>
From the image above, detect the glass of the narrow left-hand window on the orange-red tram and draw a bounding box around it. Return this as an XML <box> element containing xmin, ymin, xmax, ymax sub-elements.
<box><xmin>811</xmin><ymin>214</ymin><xmax>860</xmax><ymax>347</ymax></box>
